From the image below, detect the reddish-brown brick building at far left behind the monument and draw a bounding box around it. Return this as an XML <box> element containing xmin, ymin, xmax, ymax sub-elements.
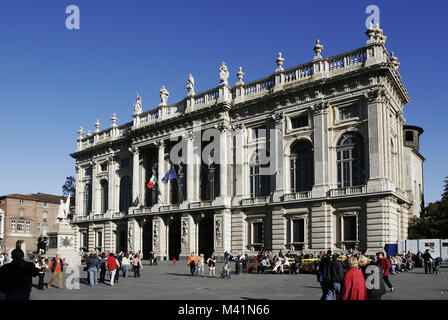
<box><xmin>0</xmin><ymin>193</ymin><xmax>65</xmax><ymax>254</ymax></box>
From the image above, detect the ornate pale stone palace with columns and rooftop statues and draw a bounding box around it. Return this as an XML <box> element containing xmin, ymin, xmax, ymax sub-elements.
<box><xmin>71</xmin><ymin>26</ymin><xmax>424</xmax><ymax>259</ymax></box>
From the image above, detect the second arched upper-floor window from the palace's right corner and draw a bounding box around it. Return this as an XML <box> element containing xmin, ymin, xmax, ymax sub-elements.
<box><xmin>290</xmin><ymin>141</ymin><xmax>314</xmax><ymax>192</ymax></box>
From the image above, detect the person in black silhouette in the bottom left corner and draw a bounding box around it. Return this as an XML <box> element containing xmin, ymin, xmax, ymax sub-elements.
<box><xmin>0</xmin><ymin>249</ymin><xmax>39</xmax><ymax>300</ymax></box>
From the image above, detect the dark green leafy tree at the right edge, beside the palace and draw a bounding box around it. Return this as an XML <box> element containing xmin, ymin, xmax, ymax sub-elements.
<box><xmin>408</xmin><ymin>177</ymin><xmax>448</xmax><ymax>239</ymax></box>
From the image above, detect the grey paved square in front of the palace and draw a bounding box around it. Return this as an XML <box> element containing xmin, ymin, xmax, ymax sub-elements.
<box><xmin>31</xmin><ymin>261</ymin><xmax>448</xmax><ymax>301</ymax></box>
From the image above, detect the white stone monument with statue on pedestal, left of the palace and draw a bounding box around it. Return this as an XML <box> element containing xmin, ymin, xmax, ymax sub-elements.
<box><xmin>47</xmin><ymin>197</ymin><xmax>81</xmax><ymax>266</ymax></box>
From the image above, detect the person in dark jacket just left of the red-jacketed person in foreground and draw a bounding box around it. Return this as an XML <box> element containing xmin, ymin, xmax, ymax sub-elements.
<box><xmin>323</xmin><ymin>252</ymin><xmax>344</xmax><ymax>300</ymax></box>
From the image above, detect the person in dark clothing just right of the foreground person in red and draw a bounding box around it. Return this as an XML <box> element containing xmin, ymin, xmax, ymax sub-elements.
<box><xmin>358</xmin><ymin>256</ymin><xmax>386</xmax><ymax>300</ymax></box>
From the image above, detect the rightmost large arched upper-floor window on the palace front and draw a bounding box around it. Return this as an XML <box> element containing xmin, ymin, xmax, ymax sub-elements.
<box><xmin>336</xmin><ymin>132</ymin><xmax>365</xmax><ymax>188</ymax></box>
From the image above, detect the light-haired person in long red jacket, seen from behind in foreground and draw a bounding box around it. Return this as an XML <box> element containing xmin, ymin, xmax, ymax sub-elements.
<box><xmin>341</xmin><ymin>257</ymin><xmax>367</xmax><ymax>300</ymax></box>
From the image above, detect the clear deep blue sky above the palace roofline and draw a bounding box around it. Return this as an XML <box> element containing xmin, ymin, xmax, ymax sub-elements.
<box><xmin>0</xmin><ymin>0</ymin><xmax>448</xmax><ymax>202</ymax></box>
